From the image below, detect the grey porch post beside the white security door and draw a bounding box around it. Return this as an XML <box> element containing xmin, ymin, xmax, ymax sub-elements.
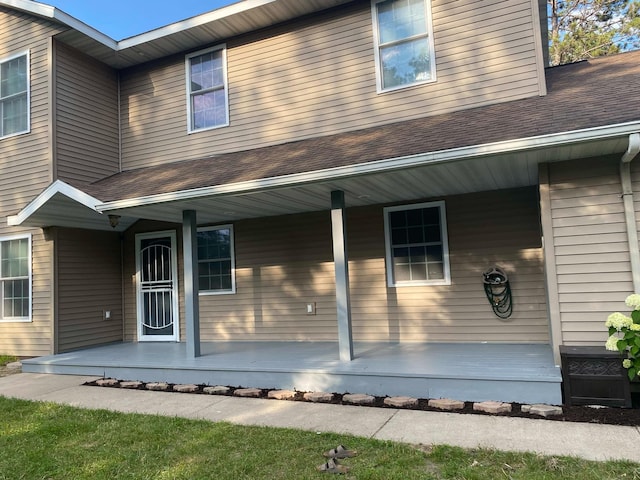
<box><xmin>182</xmin><ymin>210</ymin><xmax>200</xmax><ymax>358</ymax></box>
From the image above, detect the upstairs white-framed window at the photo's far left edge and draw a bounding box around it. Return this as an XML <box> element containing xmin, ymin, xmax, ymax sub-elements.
<box><xmin>0</xmin><ymin>52</ymin><xmax>29</xmax><ymax>138</ymax></box>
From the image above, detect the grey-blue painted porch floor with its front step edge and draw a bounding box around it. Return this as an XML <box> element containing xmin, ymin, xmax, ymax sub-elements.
<box><xmin>23</xmin><ymin>342</ymin><xmax>562</xmax><ymax>404</ymax></box>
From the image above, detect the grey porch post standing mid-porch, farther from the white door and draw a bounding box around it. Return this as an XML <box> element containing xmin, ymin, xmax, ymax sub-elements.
<box><xmin>331</xmin><ymin>190</ymin><xmax>353</xmax><ymax>361</ymax></box>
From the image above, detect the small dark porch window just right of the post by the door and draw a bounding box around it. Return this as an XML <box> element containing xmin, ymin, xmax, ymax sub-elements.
<box><xmin>198</xmin><ymin>225</ymin><xmax>236</xmax><ymax>294</ymax></box>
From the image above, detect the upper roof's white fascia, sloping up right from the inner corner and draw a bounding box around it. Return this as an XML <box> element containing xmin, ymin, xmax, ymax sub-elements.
<box><xmin>117</xmin><ymin>0</ymin><xmax>277</xmax><ymax>50</ymax></box>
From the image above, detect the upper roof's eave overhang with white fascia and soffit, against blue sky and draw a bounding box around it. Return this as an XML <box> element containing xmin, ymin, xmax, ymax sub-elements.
<box><xmin>0</xmin><ymin>0</ymin><xmax>352</xmax><ymax>69</ymax></box>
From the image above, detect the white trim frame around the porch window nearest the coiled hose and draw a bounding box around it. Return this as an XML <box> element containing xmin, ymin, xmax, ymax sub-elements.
<box><xmin>383</xmin><ymin>200</ymin><xmax>451</xmax><ymax>287</ymax></box>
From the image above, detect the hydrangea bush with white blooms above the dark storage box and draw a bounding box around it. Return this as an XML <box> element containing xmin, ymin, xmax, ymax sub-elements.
<box><xmin>605</xmin><ymin>294</ymin><xmax>640</xmax><ymax>380</ymax></box>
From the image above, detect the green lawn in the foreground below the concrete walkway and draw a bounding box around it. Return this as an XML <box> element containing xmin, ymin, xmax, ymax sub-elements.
<box><xmin>0</xmin><ymin>397</ymin><xmax>640</xmax><ymax>480</ymax></box>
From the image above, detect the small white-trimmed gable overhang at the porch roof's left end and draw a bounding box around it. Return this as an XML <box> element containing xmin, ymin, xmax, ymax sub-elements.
<box><xmin>7</xmin><ymin>180</ymin><xmax>135</xmax><ymax>231</ymax></box>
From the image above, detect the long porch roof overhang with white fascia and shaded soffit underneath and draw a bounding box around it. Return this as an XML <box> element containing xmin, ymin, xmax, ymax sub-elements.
<box><xmin>96</xmin><ymin>121</ymin><xmax>640</xmax><ymax>224</ymax></box>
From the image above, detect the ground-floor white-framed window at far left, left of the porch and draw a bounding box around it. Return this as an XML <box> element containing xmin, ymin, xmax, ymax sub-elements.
<box><xmin>0</xmin><ymin>237</ymin><xmax>31</xmax><ymax>321</ymax></box>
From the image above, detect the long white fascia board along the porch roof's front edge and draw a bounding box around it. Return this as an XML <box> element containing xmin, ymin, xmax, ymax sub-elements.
<box><xmin>96</xmin><ymin>121</ymin><xmax>640</xmax><ymax>212</ymax></box>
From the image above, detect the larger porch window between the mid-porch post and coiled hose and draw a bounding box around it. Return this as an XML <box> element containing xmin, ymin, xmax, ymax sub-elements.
<box><xmin>384</xmin><ymin>201</ymin><xmax>451</xmax><ymax>287</ymax></box>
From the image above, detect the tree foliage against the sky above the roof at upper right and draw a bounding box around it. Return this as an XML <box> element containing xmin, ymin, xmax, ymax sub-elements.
<box><xmin>547</xmin><ymin>0</ymin><xmax>640</xmax><ymax>65</ymax></box>
